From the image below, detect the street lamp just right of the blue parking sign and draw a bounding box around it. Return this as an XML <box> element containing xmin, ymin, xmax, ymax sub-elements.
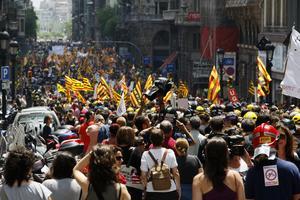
<box><xmin>9</xmin><ymin>41</ymin><xmax>19</xmax><ymax>101</ymax></box>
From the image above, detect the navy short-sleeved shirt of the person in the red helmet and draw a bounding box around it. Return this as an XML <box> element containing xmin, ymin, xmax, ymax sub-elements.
<box><xmin>245</xmin><ymin>159</ymin><xmax>300</xmax><ymax>200</ymax></box>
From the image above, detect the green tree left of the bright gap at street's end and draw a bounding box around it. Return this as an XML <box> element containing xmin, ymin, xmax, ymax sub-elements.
<box><xmin>25</xmin><ymin>8</ymin><xmax>38</xmax><ymax>38</ymax></box>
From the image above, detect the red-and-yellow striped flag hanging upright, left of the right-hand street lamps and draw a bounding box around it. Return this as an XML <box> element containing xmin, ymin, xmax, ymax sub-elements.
<box><xmin>207</xmin><ymin>66</ymin><xmax>221</xmax><ymax>103</ymax></box>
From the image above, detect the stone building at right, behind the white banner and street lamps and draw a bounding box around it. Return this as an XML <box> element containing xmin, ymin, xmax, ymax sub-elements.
<box><xmin>225</xmin><ymin>0</ymin><xmax>300</xmax><ymax>102</ymax></box>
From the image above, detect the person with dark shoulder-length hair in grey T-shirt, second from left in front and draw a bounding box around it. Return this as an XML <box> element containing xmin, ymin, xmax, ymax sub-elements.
<box><xmin>43</xmin><ymin>152</ymin><xmax>81</xmax><ymax>200</ymax></box>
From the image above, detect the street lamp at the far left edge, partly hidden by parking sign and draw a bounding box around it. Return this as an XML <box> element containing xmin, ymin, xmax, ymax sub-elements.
<box><xmin>0</xmin><ymin>31</ymin><xmax>9</xmax><ymax>120</ymax></box>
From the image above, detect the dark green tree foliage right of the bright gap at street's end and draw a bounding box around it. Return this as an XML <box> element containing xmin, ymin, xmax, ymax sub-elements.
<box><xmin>97</xmin><ymin>7</ymin><xmax>120</xmax><ymax>39</ymax></box>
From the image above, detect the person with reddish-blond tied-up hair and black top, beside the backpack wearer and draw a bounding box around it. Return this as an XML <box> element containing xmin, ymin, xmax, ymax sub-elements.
<box><xmin>176</xmin><ymin>138</ymin><xmax>202</xmax><ymax>200</ymax></box>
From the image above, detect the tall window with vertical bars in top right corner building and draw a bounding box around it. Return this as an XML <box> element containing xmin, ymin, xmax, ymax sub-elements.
<box><xmin>264</xmin><ymin>0</ymin><xmax>287</xmax><ymax>27</ymax></box>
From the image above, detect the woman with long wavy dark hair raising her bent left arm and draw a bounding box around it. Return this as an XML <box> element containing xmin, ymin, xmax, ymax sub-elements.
<box><xmin>73</xmin><ymin>144</ymin><xmax>130</xmax><ymax>200</ymax></box>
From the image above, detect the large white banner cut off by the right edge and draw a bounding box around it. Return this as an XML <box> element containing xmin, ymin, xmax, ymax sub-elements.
<box><xmin>280</xmin><ymin>28</ymin><xmax>300</xmax><ymax>99</ymax></box>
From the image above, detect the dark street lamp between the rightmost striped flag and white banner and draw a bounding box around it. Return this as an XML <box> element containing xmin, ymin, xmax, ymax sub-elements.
<box><xmin>256</xmin><ymin>36</ymin><xmax>275</xmax><ymax>103</ymax></box>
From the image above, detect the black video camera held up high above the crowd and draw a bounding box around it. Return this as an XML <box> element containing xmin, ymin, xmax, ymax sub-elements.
<box><xmin>145</xmin><ymin>77</ymin><xmax>173</xmax><ymax>101</ymax></box>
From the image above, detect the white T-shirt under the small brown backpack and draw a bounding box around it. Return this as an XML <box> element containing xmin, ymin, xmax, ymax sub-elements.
<box><xmin>141</xmin><ymin>148</ymin><xmax>178</xmax><ymax>192</ymax></box>
